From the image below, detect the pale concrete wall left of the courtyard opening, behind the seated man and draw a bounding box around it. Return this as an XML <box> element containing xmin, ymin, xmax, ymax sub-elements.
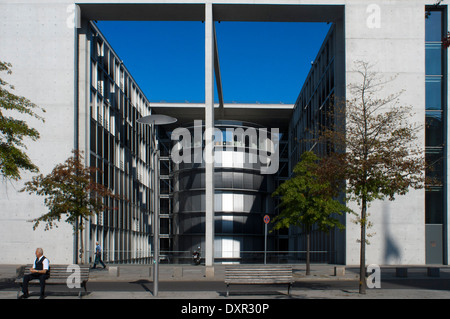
<box><xmin>0</xmin><ymin>1</ymin><xmax>74</xmax><ymax>264</ymax></box>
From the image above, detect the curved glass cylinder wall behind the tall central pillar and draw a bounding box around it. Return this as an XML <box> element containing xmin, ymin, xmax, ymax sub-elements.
<box><xmin>173</xmin><ymin>121</ymin><xmax>273</xmax><ymax>262</ymax></box>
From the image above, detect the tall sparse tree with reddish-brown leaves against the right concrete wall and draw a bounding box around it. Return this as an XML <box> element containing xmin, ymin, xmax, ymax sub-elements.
<box><xmin>320</xmin><ymin>61</ymin><xmax>425</xmax><ymax>294</ymax></box>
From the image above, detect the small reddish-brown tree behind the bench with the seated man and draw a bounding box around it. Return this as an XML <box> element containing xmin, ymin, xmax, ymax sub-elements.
<box><xmin>21</xmin><ymin>150</ymin><xmax>118</xmax><ymax>262</ymax></box>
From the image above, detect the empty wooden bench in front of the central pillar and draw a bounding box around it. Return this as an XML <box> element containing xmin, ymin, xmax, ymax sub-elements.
<box><xmin>225</xmin><ymin>265</ymin><xmax>294</xmax><ymax>297</ymax></box>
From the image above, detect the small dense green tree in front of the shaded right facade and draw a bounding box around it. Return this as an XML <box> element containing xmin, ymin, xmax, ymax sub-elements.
<box><xmin>272</xmin><ymin>152</ymin><xmax>348</xmax><ymax>275</ymax></box>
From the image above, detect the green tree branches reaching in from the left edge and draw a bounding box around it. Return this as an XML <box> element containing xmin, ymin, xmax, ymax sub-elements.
<box><xmin>0</xmin><ymin>61</ymin><xmax>45</xmax><ymax>180</ymax></box>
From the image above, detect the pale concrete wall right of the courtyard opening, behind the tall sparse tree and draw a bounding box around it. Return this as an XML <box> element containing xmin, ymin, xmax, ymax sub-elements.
<box><xmin>345</xmin><ymin>1</ymin><xmax>425</xmax><ymax>264</ymax></box>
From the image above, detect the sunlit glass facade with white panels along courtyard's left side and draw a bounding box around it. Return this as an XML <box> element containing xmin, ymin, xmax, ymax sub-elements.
<box><xmin>86</xmin><ymin>23</ymin><xmax>154</xmax><ymax>263</ymax></box>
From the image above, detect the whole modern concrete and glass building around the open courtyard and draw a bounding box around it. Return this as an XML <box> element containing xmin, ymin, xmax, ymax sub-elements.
<box><xmin>0</xmin><ymin>0</ymin><xmax>450</xmax><ymax>267</ymax></box>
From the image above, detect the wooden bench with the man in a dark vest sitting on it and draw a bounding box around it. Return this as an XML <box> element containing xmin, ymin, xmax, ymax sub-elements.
<box><xmin>15</xmin><ymin>264</ymin><xmax>89</xmax><ymax>298</ymax></box>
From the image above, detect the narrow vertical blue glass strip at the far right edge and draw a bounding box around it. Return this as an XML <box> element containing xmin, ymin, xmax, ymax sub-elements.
<box><xmin>425</xmin><ymin>8</ymin><xmax>447</xmax><ymax>263</ymax></box>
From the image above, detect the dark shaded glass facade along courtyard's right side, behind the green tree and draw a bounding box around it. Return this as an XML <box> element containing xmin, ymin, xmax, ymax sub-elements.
<box><xmin>289</xmin><ymin>25</ymin><xmax>337</xmax><ymax>262</ymax></box>
